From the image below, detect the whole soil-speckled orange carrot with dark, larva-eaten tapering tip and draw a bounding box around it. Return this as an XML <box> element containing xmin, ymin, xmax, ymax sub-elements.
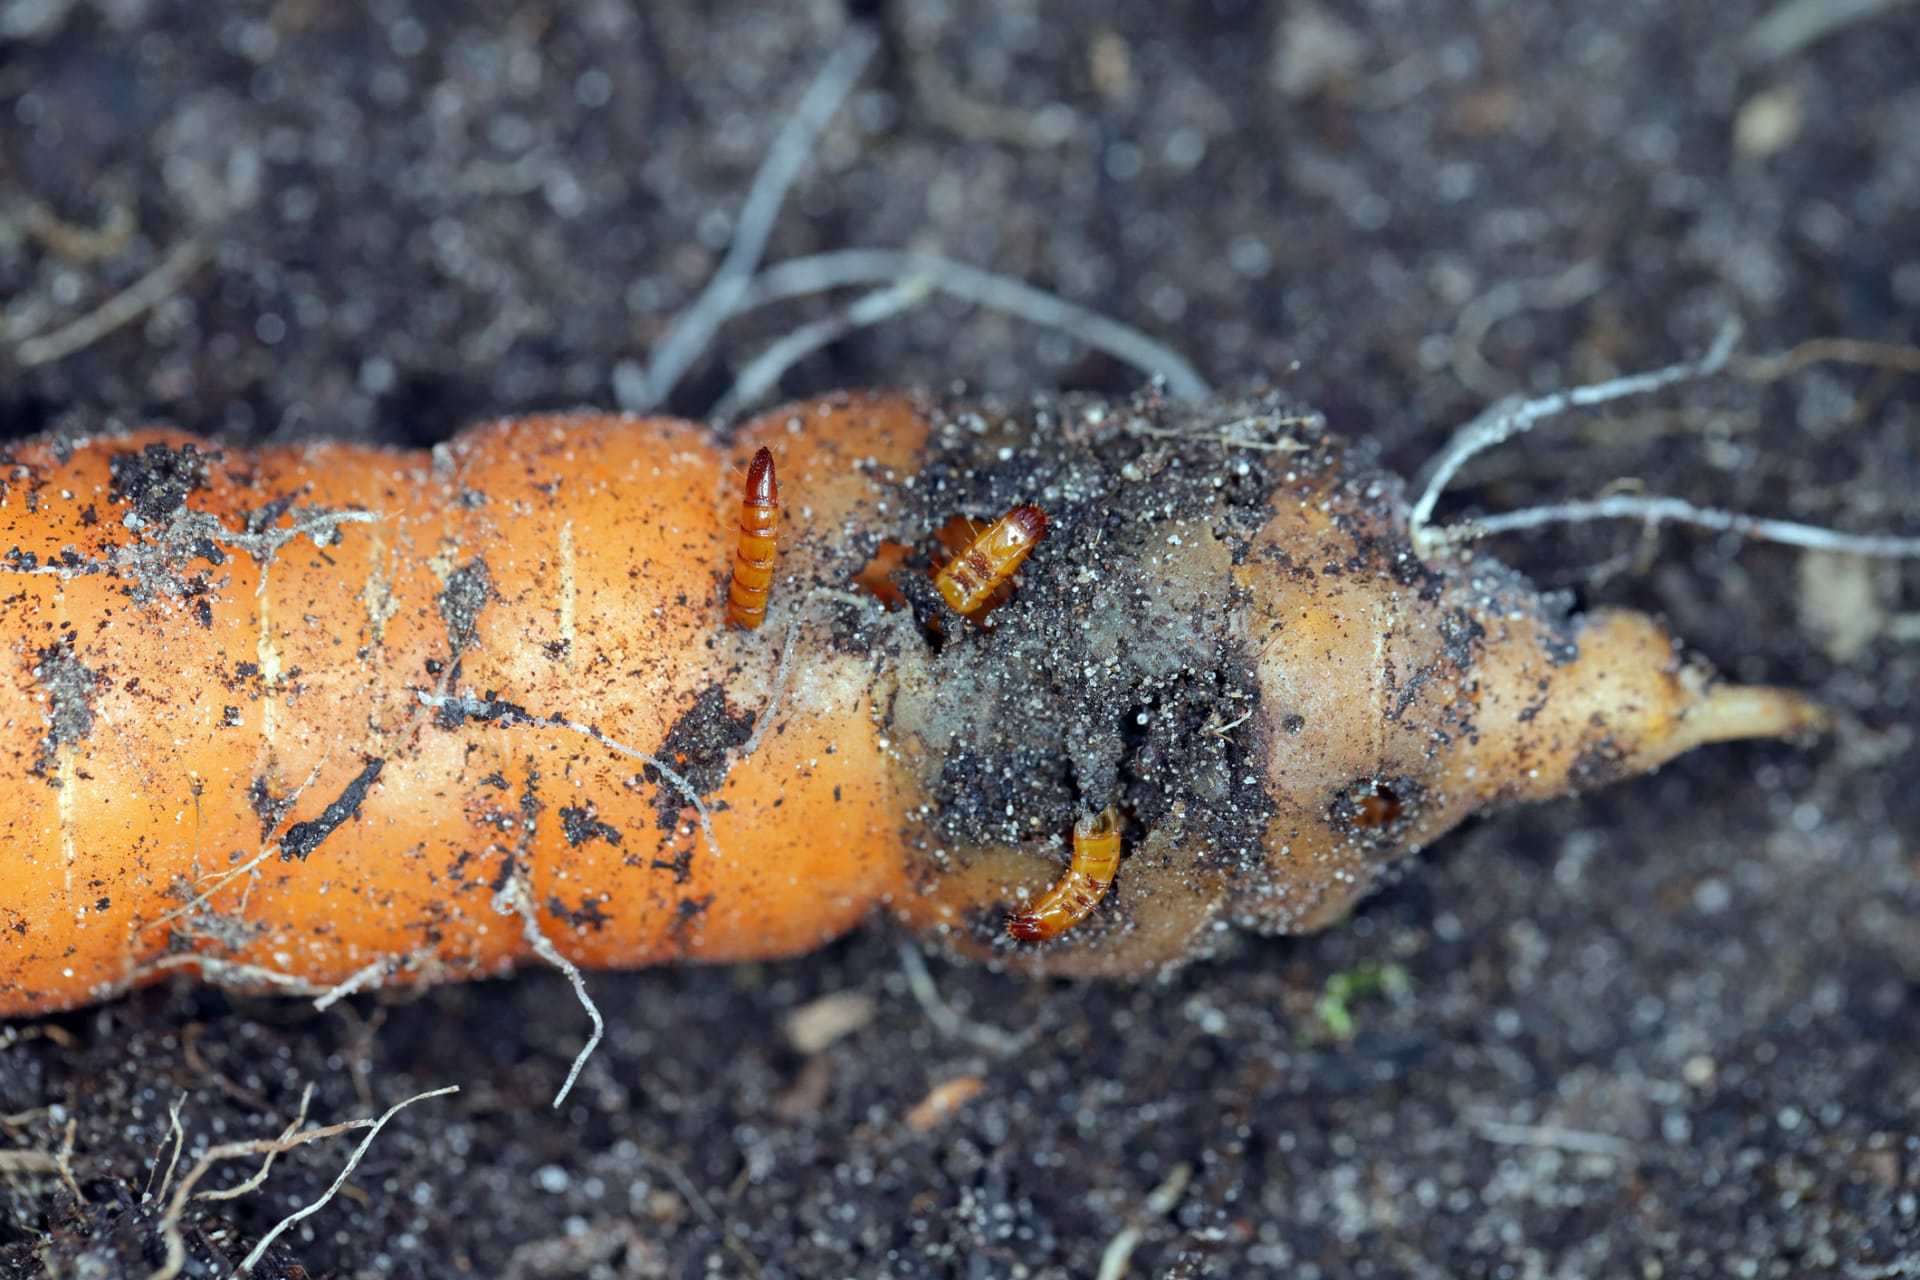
<box><xmin>0</xmin><ymin>397</ymin><xmax>1822</xmax><ymax>1015</ymax></box>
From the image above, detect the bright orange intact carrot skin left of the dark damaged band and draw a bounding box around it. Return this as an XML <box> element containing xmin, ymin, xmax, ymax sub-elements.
<box><xmin>0</xmin><ymin>402</ymin><xmax>929</xmax><ymax>1015</ymax></box>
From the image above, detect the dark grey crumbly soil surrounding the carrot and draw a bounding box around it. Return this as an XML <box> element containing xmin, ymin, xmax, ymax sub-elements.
<box><xmin>0</xmin><ymin>0</ymin><xmax>1920</xmax><ymax>1278</ymax></box>
